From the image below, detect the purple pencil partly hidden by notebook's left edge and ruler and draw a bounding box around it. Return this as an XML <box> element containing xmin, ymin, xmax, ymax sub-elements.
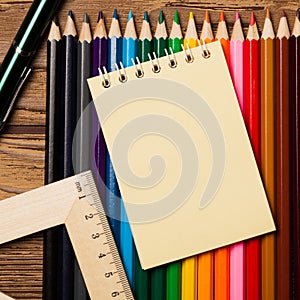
<box><xmin>91</xmin><ymin>12</ymin><xmax>108</xmax><ymax>204</ymax></box>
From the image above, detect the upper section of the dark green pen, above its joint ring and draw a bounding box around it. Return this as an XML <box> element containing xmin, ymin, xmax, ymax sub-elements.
<box><xmin>14</xmin><ymin>0</ymin><xmax>61</xmax><ymax>52</ymax></box>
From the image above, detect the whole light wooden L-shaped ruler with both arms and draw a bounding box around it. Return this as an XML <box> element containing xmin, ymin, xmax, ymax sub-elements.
<box><xmin>0</xmin><ymin>171</ymin><xmax>134</xmax><ymax>300</ymax></box>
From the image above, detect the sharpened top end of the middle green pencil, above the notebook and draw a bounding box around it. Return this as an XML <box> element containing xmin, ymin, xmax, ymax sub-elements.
<box><xmin>153</xmin><ymin>10</ymin><xmax>168</xmax><ymax>57</ymax></box>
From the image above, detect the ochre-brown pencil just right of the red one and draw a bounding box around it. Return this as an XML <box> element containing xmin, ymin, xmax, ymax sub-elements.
<box><xmin>261</xmin><ymin>10</ymin><xmax>276</xmax><ymax>299</ymax></box>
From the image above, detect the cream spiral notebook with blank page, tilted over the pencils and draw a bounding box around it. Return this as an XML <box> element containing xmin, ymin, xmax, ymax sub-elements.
<box><xmin>88</xmin><ymin>42</ymin><xmax>275</xmax><ymax>269</ymax></box>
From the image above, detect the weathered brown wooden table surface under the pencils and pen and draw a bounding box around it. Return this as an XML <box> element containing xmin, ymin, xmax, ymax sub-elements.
<box><xmin>0</xmin><ymin>0</ymin><xmax>299</xmax><ymax>299</ymax></box>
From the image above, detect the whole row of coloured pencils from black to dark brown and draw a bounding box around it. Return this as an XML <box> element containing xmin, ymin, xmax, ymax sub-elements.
<box><xmin>44</xmin><ymin>6</ymin><xmax>300</xmax><ymax>300</ymax></box>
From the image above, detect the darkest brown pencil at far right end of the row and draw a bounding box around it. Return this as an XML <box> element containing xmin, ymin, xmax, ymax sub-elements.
<box><xmin>289</xmin><ymin>9</ymin><xmax>300</xmax><ymax>299</ymax></box>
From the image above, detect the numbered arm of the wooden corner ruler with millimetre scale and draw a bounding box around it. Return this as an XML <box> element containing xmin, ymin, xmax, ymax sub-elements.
<box><xmin>66</xmin><ymin>172</ymin><xmax>133</xmax><ymax>299</ymax></box>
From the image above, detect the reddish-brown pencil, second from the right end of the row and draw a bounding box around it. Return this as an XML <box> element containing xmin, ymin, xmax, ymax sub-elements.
<box><xmin>275</xmin><ymin>12</ymin><xmax>291</xmax><ymax>300</ymax></box>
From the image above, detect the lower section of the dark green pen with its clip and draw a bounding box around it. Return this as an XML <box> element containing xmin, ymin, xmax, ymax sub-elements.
<box><xmin>0</xmin><ymin>46</ymin><xmax>31</xmax><ymax>127</ymax></box>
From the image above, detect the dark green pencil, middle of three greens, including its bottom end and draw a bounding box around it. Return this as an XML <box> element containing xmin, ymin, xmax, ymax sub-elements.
<box><xmin>151</xmin><ymin>10</ymin><xmax>168</xmax><ymax>300</ymax></box>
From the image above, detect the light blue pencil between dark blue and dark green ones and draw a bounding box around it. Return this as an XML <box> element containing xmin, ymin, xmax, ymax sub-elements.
<box><xmin>120</xmin><ymin>11</ymin><xmax>137</xmax><ymax>291</ymax></box>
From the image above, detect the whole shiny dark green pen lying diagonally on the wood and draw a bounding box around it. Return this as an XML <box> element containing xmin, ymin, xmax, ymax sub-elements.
<box><xmin>0</xmin><ymin>0</ymin><xmax>61</xmax><ymax>130</ymax></box>
